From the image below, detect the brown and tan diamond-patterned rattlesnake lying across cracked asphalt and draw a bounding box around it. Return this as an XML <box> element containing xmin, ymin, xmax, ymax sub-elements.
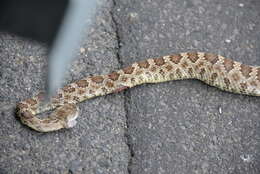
<box><xmin>17</xmin><ymin>52</ymin><xmax>260</xmax><ymax>132</ymax></box>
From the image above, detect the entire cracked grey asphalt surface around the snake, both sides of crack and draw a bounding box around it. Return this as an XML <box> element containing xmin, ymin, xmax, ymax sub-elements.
<box><xmin>0</xmin><ymin>0</ymin><xmax>260</xmax><ymax>174</ymax></box>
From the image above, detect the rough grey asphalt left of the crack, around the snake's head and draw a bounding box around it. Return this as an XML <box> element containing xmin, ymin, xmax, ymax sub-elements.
<box><xmin>0</xmin><ymin>1</ymin><xmax>129</xmax><ymax>174</ymax></box>
